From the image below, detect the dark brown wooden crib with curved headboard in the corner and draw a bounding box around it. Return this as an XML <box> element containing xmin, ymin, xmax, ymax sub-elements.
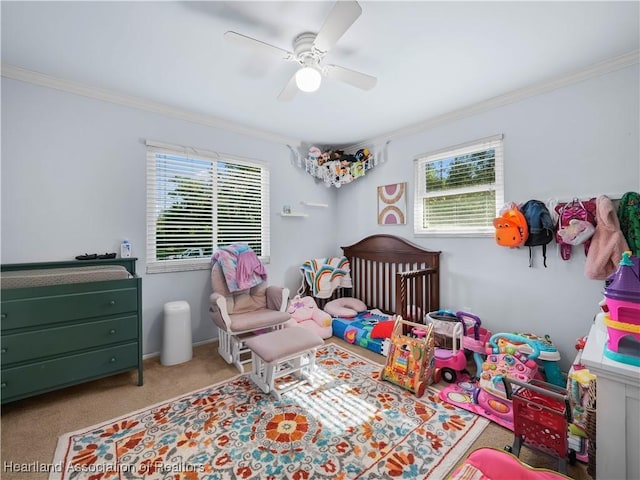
<box><xmin>304</xmin><ymin>234</ymin><xmax>440</xmax><ymax>323</ymax></box>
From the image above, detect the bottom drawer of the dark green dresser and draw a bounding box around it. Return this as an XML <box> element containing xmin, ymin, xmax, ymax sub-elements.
<box><xmin>0</xmin><ymin>343</ymin><xmax>138</xmax><ymax>403</ymax></box>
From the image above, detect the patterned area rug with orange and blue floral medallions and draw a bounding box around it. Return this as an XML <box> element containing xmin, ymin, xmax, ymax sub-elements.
<box><xmin>50</xmin><ymin>344</ymin><xmax>489</xmax><ymax>480</ymax></box>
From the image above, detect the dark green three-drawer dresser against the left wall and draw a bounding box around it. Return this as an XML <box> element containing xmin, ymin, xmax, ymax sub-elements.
<box><xmin>0</xmin><ymin>258</ymin><xmax>143</xmax><ymax>403</ymax></box>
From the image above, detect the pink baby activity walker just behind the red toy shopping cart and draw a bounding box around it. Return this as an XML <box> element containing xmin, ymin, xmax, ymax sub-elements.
<box><xmin>473</xmin><ymin>333</ymin><xmax>540</xmax><ymax>422</ymax></box>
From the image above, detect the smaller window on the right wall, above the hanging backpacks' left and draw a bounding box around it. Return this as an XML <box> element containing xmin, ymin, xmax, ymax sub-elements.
<box><xmin>413</xmin><ymin>135</ymin><xmax>504</xmax><ymax>235</ymax></box>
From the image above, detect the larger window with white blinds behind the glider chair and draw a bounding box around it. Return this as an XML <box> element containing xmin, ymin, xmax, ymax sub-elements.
<box><xmin>147</xmin><ymin>142</ymin><xmax>270</xmax><ymax>273</ymax></box>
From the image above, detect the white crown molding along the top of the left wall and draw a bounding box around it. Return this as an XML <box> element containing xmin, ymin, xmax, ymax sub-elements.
<box><xmin>2</xmin><ymin>63</ymin><xmax>300</xmax><ymax>146</ymax></box>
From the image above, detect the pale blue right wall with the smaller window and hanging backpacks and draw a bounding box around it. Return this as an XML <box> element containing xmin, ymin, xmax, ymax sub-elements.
<box><xmin>338</xmin><ymin>65</ymin><xmax>640</xmax><ymax>370</ymax></box>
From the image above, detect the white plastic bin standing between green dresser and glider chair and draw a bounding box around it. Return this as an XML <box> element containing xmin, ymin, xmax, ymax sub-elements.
<box><xmin>160</xmin><ymin>301</ymin><xmax>193</xmax><ymax>365</ymax></box>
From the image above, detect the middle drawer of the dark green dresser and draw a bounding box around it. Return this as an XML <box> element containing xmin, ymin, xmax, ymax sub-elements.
<box><xmin>0</xmin><ymin>315</ymin><xmax>138</xmax><ymax>366</ymax></box>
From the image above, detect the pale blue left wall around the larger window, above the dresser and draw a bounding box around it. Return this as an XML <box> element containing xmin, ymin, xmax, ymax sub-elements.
<box><xmin>1</xmin><ymin>78</ymin><xmax>335</xmax><ymax>354</ymax></box>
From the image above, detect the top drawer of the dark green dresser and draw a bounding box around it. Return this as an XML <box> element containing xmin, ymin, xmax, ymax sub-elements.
<box><xmin>1</xmin><ymin>288</ymin><xmax>138</xmax><ymax>333</ymax></box>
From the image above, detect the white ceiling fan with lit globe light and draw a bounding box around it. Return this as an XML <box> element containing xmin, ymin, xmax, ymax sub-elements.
<box><xmin>224</xmin><ymin>1</ymin><xmax>377</xmax><ymax>101</ymax></box>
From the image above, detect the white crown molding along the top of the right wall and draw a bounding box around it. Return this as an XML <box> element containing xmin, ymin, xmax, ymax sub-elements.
<box><xmin>350</xmin><ymin>50</ymin><xmax>640</xmax><ymax>149</ymax></box>
